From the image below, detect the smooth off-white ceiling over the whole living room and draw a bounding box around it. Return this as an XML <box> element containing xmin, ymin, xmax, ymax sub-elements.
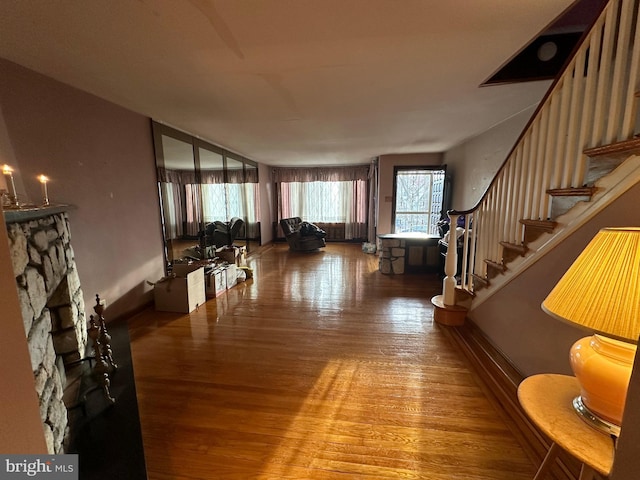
<box><xmin>0</xmin><ymin>0</ymin><xmax>572</xmax><ymax>165</ymax></box>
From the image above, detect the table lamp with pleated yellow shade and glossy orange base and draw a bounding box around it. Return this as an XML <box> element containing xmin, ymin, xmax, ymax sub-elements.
<box><xmin>542</xmin><ymin>227</ymin><xmax>640</xmax><ymax>436</ymax></box>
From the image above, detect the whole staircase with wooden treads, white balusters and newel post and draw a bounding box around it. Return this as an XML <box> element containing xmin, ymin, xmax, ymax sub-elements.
<box><xmin>432</xmin><ymin>0</ymin><xmax>640</xmax><ymax>325</ymax></box>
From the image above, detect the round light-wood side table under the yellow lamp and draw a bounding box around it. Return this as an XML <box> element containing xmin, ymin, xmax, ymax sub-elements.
<box><xmin>518</xmin><ymin>374</ymin><xmax>615</xmax><ymax>480</ymax></box>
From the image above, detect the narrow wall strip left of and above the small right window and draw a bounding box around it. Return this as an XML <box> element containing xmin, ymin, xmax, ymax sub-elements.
<box><xmin>377</xmin><ymin>153</ymin><xmax>443</xmax><ymax>234</ymax></box>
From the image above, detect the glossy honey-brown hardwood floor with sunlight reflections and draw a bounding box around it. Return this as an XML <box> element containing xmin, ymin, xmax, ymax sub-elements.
<box><xmin>129</xmin><ymin>243</ymin><xmax>535</xmax><ymax>480</ymax></box>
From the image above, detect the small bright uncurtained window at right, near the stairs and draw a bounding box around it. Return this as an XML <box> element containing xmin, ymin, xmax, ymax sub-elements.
<box><xmin>393</xmin><ymin>167</ymin><xmax>445</xmax><ymax>235</ymax></box>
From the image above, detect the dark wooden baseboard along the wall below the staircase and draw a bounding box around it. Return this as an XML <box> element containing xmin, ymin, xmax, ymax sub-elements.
<box><xmin>439</xmin><ymin>319</ymin><xmax>580</xmax><ymax>480</ymax></box>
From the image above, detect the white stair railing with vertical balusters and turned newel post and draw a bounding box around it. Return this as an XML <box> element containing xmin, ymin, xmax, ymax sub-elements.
<box><xmin>443</xmin><ymin>0</ymin><xmax>640</xmax><ymax>305</ymax></box>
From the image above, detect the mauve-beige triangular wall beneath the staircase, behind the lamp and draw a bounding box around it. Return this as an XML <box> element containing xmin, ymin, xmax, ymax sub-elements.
<box><xmin>469</xmin><ymin>184</ymin><xmax>640</xmax><ymax>375</ymax></box>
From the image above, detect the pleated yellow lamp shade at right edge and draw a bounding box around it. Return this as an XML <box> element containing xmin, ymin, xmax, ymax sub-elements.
<box><xmin>542</xmin><ymin>227</ymin><xmax>640</xmax><ymax>343</ymax></box>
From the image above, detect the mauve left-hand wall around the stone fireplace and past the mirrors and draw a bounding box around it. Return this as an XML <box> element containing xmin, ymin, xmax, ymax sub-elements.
<box><xmin>0</xmin><ymin>59</ymin><xmax>282</xmax><ymax>454</ymax></box>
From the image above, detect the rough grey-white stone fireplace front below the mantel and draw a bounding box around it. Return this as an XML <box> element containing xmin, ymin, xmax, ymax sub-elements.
<box><xmin>6</xmin><ymin>212</ymin><xmax>87</xmax><ymax>454</ymax></box>
